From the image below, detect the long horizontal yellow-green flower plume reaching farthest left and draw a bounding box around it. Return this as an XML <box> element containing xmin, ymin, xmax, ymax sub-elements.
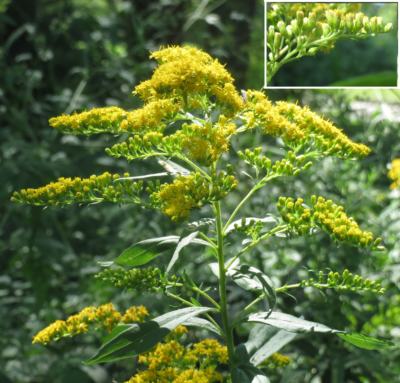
<box><xmin>11</xmin><ymin>172</ymin><xmax>143</xmax><ymax>206</ymax></box>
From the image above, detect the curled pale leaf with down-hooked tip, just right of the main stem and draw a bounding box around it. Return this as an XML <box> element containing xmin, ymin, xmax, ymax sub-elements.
<box><xmin>227</xmin><ymin>265</ymin><xmax>276</xmax><ymax>309</ymax></box>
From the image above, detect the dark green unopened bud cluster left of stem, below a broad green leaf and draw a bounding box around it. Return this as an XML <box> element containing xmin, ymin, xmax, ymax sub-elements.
<box><xmin>95</xmin><ymin>266</ymin><xmax>166</xmax><ymax>291</ymax></box>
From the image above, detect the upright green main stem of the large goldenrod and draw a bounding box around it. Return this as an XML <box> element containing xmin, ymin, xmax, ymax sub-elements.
<box><xmin>214</xmin><ymin>201</ymin><xmax>236</xmax><ymax>370</ymax></box>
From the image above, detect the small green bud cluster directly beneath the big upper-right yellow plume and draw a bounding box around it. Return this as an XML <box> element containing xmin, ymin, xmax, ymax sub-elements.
<box><xmin>238</xmin><ymin>148</ymin><xmax>312</xmax><ymax>181</ymax></box>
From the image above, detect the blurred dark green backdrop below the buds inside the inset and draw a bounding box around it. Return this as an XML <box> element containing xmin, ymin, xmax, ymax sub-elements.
<box><xmin>268</xmin><ymin>3</ymin><xmax>398</xmax><ymax>87</ymax></box>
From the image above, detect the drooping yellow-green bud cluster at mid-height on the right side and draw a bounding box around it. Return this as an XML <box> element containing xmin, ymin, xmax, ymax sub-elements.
<box><xmin>277</xmin><ymin>196</ymin><xmax>385</xmax><ymax>250</ymax></box>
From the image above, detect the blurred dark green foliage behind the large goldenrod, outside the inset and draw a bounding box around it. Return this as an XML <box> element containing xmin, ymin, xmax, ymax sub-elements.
<box><xmin>0</xmin><ymin>0</ymin><xmax>400</xmax><ymax>383</ymax></box>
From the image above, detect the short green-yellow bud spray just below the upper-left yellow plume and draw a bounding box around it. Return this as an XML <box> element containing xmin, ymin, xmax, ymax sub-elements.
<box><xmin>106</xmin><ymin>134</ymin><xmax>165</xmax><ymax>160</ymax></box>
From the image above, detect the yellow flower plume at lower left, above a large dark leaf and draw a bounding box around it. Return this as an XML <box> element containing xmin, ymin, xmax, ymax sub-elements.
<box><xmin>32</xmin><ymin>303</ymin><xmax>149</xmax><ymax>345</ymax></box>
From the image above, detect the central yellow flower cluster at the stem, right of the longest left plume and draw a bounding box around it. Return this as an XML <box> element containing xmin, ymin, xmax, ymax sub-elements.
<box><xmin>146</xmin><ymin>171</ymin><xmax>238</xmax><ymax>222</ymax></box>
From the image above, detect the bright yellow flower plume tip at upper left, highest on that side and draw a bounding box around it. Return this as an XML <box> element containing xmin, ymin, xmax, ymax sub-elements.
<box><xmin>49</xmin><ymin>106</ymin><xmax>127</xmax><ymax>134</ymax></box>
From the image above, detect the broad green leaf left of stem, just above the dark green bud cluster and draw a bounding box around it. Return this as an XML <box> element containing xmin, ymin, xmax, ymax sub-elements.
<box><xmin>99</xmin><ymin>235</ymin><xmax>211</xmax><ymax>267</ymax></box>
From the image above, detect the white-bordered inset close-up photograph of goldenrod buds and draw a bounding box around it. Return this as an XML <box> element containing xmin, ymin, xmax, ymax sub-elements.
<box><xmin>265</xmin><ymin>2</ymin><xmax>398</xmax><ymax>87</ymax></box>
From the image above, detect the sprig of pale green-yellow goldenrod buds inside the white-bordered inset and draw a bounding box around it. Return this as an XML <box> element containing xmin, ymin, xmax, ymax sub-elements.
<box><xmin>266</xmin><ymin>3</ymin><xmax>393</xmax><ymax>84</ymax></box>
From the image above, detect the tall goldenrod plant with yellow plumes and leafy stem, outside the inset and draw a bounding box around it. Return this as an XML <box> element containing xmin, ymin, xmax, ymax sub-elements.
<box><xmin>11</xmin><ymin>47</ymin><xmax>393</xmax><ymax>383</ymax></box>
